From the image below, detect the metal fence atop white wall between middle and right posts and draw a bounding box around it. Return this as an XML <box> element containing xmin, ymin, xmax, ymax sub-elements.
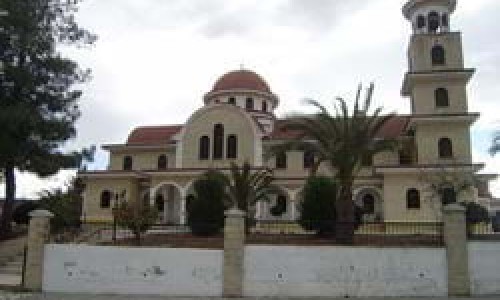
<box><xmin>246</xmin><ymin>221</ymin><xmax>443</xmax><ymax>246</ymax></box>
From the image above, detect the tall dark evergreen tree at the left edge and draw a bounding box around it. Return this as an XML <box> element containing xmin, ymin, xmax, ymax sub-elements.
<box><xmin>0</xmin><ymin>0</ymin><xmax>96</xmax><ymax>235</ymax></box>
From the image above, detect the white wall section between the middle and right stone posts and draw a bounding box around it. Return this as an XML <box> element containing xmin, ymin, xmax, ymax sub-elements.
<box><xmin>244</xmin><ymin>246</ymin><xmax>447</xmax><ymax>297</ymax></box>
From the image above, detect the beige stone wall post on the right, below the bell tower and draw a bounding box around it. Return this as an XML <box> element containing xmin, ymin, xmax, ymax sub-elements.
<box><xmin>443</xmin><ymin>203</ymin><xmax>470</xmax><ymax>296</ymax></box>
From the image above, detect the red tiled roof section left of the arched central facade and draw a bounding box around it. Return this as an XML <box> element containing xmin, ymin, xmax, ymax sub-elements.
<box><xmin>127</xmin><ymin>125</ymin><xmax>182</xmax><ymax>145</ymax></box>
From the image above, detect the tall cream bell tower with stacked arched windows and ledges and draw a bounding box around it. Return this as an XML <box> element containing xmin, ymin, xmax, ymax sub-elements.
<box><xmin>402</xmin><ymin>0</ymin><xmax>478</xmax><ymax>164</ymax></box>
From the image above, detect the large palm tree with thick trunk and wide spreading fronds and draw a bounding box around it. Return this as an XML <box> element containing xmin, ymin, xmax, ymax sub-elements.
<box><xmin>271</xmin><ymin>84</ymin><xmax>396</xmax><ymax>243</ymax></box>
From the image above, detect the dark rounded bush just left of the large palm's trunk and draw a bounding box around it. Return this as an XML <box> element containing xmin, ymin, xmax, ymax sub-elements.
<box><xmin>299</xmin><ymin>177</ymin><xmax>337</xmax><ymax>235</ymax></box>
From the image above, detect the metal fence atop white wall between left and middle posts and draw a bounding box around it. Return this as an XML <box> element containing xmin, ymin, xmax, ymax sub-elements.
<box><xmin>52</xmin><ymin>223</ymin><xmax>224</xmax><ymax>249</ymax></box>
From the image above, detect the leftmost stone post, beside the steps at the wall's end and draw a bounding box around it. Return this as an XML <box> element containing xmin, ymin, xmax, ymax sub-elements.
<box><xmin>23</xmin><ymin>209</ymin><xmax>54</xmax><ymax>291</ymax></box>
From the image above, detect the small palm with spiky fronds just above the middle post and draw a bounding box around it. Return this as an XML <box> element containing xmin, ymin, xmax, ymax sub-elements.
<box><xmin>225</xmin><ymin>162</ymin><xmax>279</xmax><ymax>223</ymax></box>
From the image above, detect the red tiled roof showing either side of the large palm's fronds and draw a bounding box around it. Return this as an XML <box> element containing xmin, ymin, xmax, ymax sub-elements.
<box><xmin>269</xmin><ymin>116</ymin><xmax>410</xmax><ymax>140</ymax></box>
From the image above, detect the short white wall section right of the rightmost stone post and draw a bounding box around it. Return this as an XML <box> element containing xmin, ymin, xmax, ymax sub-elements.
<box><xmin>468</xmin><ymin>241</ymin><xmax>500</xmax><ymax>295</ymax></box>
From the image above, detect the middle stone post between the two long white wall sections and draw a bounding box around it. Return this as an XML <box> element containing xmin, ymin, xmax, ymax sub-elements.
<box><xmin>223</xmin><ymin>208</ymin><xmax>246</xmax><ymax>297</ymax></box>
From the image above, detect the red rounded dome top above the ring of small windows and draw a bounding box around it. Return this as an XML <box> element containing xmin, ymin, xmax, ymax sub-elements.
<box><xmin>211</xmin><ymin>70</ymin><xmax>271</xmax><ymax>93</ymax></box>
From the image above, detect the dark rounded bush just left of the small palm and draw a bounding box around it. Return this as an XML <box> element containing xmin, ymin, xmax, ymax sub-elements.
<box><xmin>188</xmin><ymin>171</ymin><xmax>226</xmax><ymax>236</ymax></box>
